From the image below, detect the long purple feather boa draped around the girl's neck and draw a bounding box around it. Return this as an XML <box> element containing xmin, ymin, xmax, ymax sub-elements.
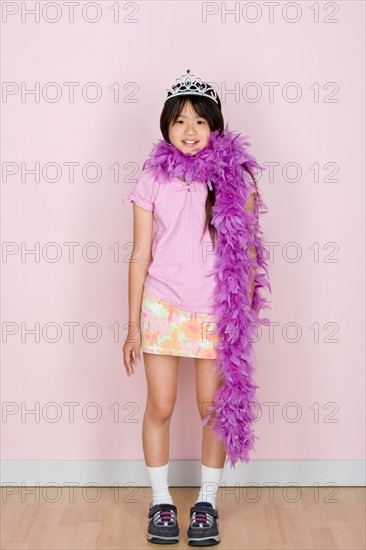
<box><xmin>143</xmin><ymin>125</ymin><xmax>271</xmax><ymax>467</ymax></box>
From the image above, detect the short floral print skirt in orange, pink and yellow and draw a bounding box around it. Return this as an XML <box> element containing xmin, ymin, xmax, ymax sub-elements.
<box><xmin>140</xmin><ymin>287</ymin><xmax>218</xmax><ymax>359</ymax></box>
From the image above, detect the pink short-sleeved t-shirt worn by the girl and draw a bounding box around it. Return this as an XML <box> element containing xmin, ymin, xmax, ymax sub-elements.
<box><xmin>122</xmin><ymin>168</ymin><xmax>215</xmax><ymax>313</ymax></box>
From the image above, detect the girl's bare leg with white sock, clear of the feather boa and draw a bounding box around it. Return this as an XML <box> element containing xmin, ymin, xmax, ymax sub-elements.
<box><xmin>142</xmin><ymin>352</ymin><xmax>179</xmax><ymax>506</ymax></box>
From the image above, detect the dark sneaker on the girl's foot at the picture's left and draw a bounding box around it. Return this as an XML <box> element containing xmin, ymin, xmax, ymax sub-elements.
<box><xmin>147</xmin><ymin>502</ymin><xmax>179</xmax><ymax>544</ymax></box>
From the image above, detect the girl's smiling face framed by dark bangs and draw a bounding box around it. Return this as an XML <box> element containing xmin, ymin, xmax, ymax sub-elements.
<box><xmin>169</xmin><ymin>101</ymin><xmax>210</xmax><ymax>155</ymax></box>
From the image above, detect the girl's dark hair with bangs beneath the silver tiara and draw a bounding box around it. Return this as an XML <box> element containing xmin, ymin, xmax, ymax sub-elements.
<box><xmin>160</xmin><ymin>95</ymin><xmax>256</xmax><ymax>244</ymax></box>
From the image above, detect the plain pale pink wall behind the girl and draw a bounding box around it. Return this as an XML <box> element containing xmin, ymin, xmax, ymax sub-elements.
<box><xmin>1</xmin><ymin>1</ymin><xmax>365</xmax><ymax>460</ymax></box>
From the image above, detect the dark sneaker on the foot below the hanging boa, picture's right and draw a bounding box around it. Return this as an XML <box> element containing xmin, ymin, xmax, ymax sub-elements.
<box><xmin>187</xmin><ymin>502</ymin><xmax>220</xmax><ymax>546</ymax></box>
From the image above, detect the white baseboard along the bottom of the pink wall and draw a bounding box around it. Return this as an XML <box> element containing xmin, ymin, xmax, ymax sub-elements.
<box><xmin>0</xmin><ymin>460</ymin><xmax>366</xmax><ymax>487</ymax></box>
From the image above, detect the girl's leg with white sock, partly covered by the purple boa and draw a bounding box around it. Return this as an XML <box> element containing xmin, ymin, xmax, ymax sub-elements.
<box><xmin>195</xmin><ymin>359</ymin><xmax>226</xmax><ymax>507</ymax></box>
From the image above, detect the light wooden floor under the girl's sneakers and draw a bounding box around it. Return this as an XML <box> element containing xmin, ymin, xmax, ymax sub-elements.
<box><xmin>0</xmin><ymin>487</ymin><xmax>366</xmax><ymax>550</ymax></box>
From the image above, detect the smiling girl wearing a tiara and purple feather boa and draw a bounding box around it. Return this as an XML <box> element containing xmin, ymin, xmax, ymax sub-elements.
<box><xmin>123</xmin><ymin>70</ymin><xmax>270</xmax><ymax>546</ymax></box>
